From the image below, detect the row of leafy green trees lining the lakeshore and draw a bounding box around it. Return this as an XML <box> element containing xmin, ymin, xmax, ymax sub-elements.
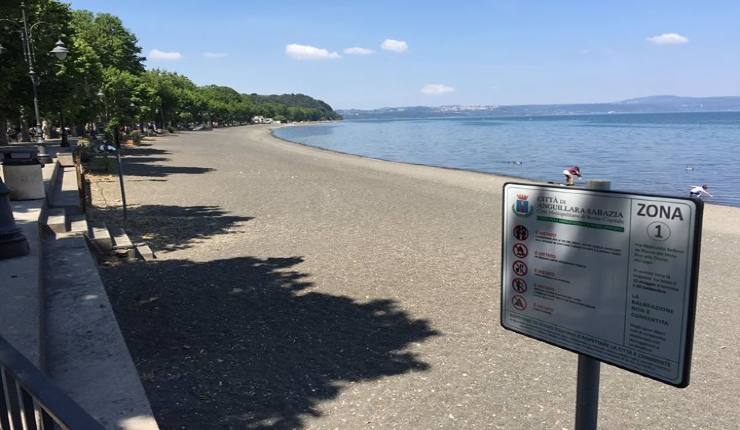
<box><xmin>0</xmin><ymin>0</ymin><xmax>340</xmax><ymax>144</ymax></box>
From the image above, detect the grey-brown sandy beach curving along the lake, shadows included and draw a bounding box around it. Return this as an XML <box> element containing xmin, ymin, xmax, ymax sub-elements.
<box><xmin>99</xmin><ymin>126</ymin><xmax>740</xmax><ymax>429</ymax></box>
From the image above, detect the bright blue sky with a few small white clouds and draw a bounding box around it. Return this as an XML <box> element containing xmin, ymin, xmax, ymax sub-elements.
<box><xmin>71</xmin><ymin>0</ymin><xmax>740</xmax><ymax>109</ymax></box>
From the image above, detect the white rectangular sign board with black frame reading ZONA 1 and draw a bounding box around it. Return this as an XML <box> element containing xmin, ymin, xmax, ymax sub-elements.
<box><xmin>501</xmin><ymin>183</ymin><xmax>703</xmax><ymax>387</ymax></box>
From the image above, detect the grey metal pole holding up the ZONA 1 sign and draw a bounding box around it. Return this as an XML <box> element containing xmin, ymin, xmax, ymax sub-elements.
<box><xmin>575</xmin><ymin>180</ymin><xmax>611</xmax><ymax>430</ymax></box>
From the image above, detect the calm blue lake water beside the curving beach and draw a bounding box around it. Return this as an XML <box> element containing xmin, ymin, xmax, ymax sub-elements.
<box><xmin>275</xmin><ymin>112</ymin><xmax>740</xmax><ymax>206</ymax></box>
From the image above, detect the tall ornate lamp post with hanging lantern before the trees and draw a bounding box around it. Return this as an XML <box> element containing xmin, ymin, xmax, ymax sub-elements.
<box><xmin>0</xmin><ymin>2</ymin><xmax>69</xmax><ymax>163</ymax></box>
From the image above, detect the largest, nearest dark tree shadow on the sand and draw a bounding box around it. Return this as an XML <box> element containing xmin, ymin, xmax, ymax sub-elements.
<box><xmin>102</xmin><ymin>257</ymin><xmax>439</xmax><ymax>429</ymax></box>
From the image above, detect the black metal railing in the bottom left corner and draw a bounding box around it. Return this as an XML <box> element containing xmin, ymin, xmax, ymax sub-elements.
<box><xmin>0</xmin><ymin>336</ymin><xmax>104</xmax><ymax>430</ymax></box>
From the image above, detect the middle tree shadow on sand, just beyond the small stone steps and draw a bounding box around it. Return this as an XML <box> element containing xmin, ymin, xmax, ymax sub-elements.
<box><xmin>91</xmin><ymin>205</ymin><xmax>253</xmax><ymax>251</ymax></box>
